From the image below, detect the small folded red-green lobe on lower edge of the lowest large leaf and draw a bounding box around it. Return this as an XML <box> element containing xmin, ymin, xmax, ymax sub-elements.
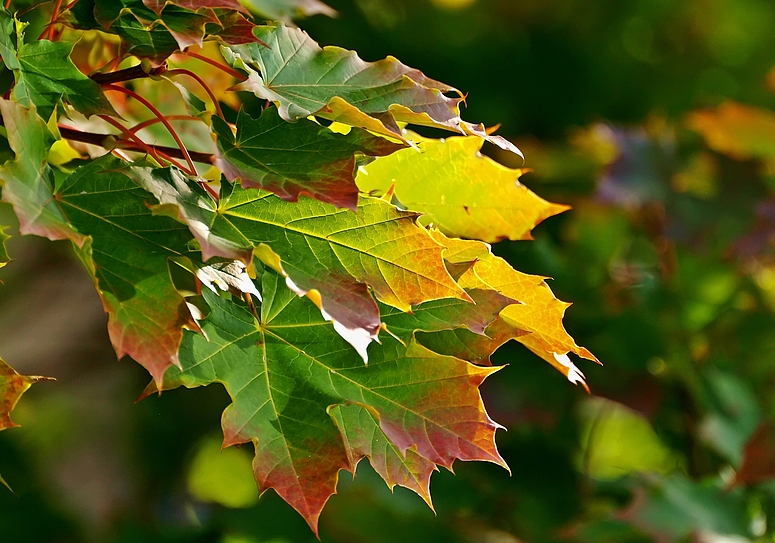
<box><xmin>328</xmin><ymin>405</ymin><xmax>437</xmax><ymax>508</ymax></box>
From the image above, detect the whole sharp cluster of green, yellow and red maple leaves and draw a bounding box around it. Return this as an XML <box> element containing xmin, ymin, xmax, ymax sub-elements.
<box><xmin>0</xmin><ymin>0</ymin><xmax>595</xmax><ymax>531</ymax></box>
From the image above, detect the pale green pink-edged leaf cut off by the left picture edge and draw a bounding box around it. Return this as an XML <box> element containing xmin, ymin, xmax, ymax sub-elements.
<box><xmin>0</xmin><ymin>99</ymin><xmax>82</xmax><ymax>243</ymax></box>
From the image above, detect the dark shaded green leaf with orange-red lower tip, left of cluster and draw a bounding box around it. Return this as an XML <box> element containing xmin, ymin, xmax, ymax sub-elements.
<box><xmin>56</xmin><ymin>155</ymin><xmax>199</xmax><ymax>381</ymax></box>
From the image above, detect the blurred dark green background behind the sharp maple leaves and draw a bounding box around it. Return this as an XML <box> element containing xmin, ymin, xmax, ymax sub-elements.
<box><xmin>0</xmin><ymin>0</ymin><xmax>775</xmax><ymax>543</ymax></box>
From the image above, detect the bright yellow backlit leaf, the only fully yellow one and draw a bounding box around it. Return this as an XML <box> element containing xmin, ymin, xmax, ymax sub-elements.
<box><xmin>357</xmin><ymin>136</ymin><xmax>568</xmax><ymax>242</ymax></box>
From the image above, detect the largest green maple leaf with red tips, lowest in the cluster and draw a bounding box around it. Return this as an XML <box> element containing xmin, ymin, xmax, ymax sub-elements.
<box><xmin>152</xmin><ymin>271</ymin><xmax>505</xmax><ymax>530</ymax></box>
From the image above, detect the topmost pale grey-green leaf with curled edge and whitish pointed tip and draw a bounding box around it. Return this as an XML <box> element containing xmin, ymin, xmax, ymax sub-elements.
<box><xmin>224</xmin><ymin>23</ymin><xmax>521</xmax><ymax>155</ymax></box>
